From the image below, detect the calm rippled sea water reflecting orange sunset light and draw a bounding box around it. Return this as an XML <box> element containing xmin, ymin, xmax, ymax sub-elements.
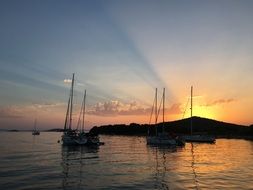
<box><xmin>0</xmin><ymin>132</ymin><xmax>253</xmax><ymax>190</ymax></box>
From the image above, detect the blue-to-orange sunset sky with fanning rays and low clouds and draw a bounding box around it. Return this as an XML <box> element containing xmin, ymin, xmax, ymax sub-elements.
<box><xmin>0</xmin><ymin>0</ymin><xmax>253</xmax><ymax>129</ymax></box>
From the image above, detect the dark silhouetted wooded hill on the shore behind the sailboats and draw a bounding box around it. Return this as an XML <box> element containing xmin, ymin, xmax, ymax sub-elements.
<box><xmin>90</xmin><ymin>117</ymin><xmax>253</xmax><ymax>140</ymax></box>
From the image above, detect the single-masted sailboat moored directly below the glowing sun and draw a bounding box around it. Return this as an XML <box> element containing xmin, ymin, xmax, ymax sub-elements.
<box><xmin>183</xmin><ymin>86</ymin><xmax>215</xmax><ymax>143</ymax></box>
